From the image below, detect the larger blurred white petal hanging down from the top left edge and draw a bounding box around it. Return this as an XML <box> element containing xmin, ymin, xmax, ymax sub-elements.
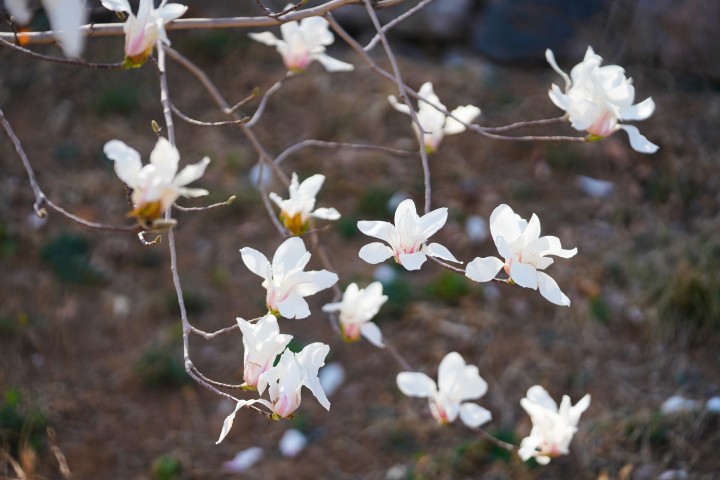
<box><xmin>43</xmin><ymin>0</ymin><xmax>87</xmax><ymax>58</ymax></box>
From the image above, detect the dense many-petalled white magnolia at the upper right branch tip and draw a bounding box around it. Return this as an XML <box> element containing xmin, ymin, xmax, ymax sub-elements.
<box><xmin>545</xmin><ymin>47</ymin><xmax>658</xmax><ymax>153</ymax></box>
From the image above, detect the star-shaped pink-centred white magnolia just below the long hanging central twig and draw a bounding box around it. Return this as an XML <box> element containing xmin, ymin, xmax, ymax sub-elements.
<box><xmin>358</xmin><ymin>199</ymin><xmax>460</xmax><ymax>270</ymax></box>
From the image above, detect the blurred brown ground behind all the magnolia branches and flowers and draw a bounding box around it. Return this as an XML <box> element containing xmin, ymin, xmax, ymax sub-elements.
<box><xmin>0</xmin><ymin>0</ymin><xmax>720</xmax><ymax>480</ymax></box>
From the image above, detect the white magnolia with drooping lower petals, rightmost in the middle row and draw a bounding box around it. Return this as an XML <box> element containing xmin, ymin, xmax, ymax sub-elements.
<box><xmin>465</xmin><ymin>204</ymin><xmax>577</xmax><ymax>306</ymax></box>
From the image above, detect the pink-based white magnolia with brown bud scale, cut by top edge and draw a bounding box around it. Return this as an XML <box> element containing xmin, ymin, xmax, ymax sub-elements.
<box><xmin>101</xmin><ymin>0</ymin><xmax>187</xmax><ymax>68</ymax></box>
